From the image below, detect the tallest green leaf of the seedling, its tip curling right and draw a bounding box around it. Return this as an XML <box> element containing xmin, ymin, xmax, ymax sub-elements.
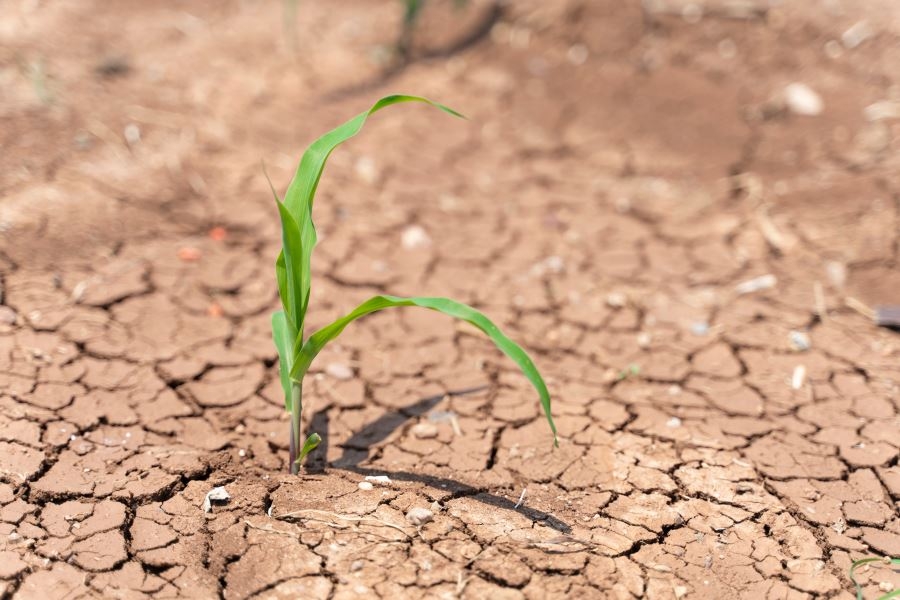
<box><xmin>276</xmin><ymin>95</ymin><xmax>462</xmax><ymax>338</ymax></box>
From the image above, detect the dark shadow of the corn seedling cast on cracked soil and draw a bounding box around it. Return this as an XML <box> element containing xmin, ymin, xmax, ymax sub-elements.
<box><xmin>305</xmin><ymin>386</ymin><xmax>572</xmax><ymax>533</ymax></box>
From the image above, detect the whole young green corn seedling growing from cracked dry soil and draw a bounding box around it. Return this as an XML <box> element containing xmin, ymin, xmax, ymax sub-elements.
<box><xmin>270</xmin><ymin>96</ymin><xmax>557</xmax><ymax>473</ymax></box>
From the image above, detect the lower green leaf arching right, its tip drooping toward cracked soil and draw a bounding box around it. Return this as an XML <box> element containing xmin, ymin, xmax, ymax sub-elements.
<box><xmin>291</xmin><ymin>295</ymin><xmax>558</xmax><ymax>445</ymax></box>
